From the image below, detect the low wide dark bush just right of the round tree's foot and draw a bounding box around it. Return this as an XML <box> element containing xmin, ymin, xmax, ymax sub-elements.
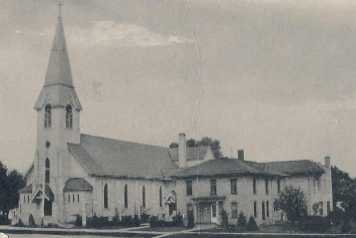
<box><xmin>299</xmin><ymin>216</ymin><xmax>330</xmax><ymax>232</ymax></box>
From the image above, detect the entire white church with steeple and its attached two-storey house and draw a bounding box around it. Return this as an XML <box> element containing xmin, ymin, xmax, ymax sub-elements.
<box><xmin>18</xmin><ymin>8</ymin><xmax>332</xmax><ymax>224</ymax></box>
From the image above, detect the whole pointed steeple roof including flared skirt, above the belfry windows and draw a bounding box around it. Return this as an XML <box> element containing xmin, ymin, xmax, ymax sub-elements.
<box><xmin>35</xmin><ymin>3</ymin><xmax>82</xmax><ymax>111</ymax></box>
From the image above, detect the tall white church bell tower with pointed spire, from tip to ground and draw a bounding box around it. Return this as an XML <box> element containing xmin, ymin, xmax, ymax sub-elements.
<box><xmin>34</xmin><ymin>3</ymin><xmax>82</xmax><ymax>222</ymax></box>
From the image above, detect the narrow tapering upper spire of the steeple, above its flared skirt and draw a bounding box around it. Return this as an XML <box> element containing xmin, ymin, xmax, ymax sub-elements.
<box><xmin>45</xmin><ymin>1</ymin><xmax>73</xmax><ymax>87</ymax></box>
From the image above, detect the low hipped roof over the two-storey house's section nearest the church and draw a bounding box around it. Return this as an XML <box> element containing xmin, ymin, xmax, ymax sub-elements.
<box><xmin>171</xmin><ymin>158</ymin><xmax>283</xmax><ymax>177</ymax></box>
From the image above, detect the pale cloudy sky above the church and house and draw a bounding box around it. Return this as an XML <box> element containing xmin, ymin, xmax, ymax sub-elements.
<box><xmin>0</xmin><ymin>0</ymin><xmax>356</xmax><ymax>176</ymax></box>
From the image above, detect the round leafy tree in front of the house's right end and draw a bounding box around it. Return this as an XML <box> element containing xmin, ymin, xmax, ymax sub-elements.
<box><xmin>274</xmin><ymin>186</ymin><xmax>307</xmax><ymax>223</ymax></box>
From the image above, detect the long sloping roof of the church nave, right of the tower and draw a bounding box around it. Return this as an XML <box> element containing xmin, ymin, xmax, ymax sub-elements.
<box><xmin>68</xmin><ymin>134</ymin><xmax>177</xmax><ymax>179</ymax></box>
